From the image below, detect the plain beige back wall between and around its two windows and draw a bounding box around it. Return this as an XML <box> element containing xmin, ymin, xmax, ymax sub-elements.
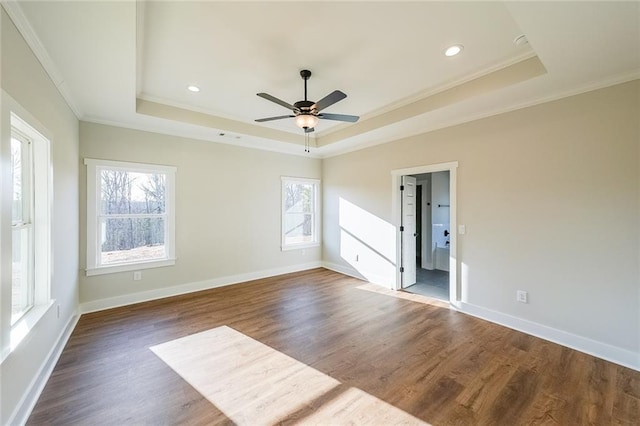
<box><xmin>80</xmin><ymin>122</ymin><xmax>321</xmax><ymax>309</ymax></box>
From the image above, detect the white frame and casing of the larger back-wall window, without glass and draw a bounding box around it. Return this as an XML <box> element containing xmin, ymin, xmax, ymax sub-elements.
<box><xmin>84</xmin><ymin>158</ymin><xmax>176</xmax><ymax>276</ymax></box>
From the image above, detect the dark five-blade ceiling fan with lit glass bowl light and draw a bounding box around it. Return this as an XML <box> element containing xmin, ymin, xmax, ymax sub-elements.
<box><xmin>256</xmin><ymin>70</ymin><xmax>360</xmax><ymax>133</ymax></box>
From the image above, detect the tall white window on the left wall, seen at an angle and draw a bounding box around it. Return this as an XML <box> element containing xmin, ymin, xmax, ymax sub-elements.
<box><xmin>11</xmin><ymin>113</ymin><xmax>51</xmax><ymax>325</ymax></box>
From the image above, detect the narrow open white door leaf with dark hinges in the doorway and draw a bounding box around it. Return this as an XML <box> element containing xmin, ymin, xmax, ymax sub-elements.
<box><xmin>400</xmin><ymin>176</ymin><xmax>416</xmax><ymax>288</ymax></box>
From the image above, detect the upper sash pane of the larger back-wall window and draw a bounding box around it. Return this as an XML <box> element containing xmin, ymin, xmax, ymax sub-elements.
<box><xmin>100</xmin><ymin>170</ymin><xmax>166</xmax><ymax>215</ymax></box>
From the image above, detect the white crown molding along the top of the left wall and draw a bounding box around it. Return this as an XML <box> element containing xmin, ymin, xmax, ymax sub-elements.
<box><xmin>1</xmin><ymin>0</ymin><xmax>82</xmax><ymax>120</ymax></box>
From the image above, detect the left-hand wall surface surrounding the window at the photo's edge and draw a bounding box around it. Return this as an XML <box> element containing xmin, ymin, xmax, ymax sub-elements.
<box><xmin>0</xmin><ymin>9</ymin><xmax>79</xmax><ymax>424</ymax></box>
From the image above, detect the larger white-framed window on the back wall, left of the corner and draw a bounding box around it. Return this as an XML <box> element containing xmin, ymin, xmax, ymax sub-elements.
<box><xmin>85</xmin><ymin>159</ymin><xmax>176</xmax><ymax>275</ymax></box>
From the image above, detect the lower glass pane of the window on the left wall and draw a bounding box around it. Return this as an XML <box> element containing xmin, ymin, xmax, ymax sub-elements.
<box><xmin>11</xmin><ymin>227</ymin><xmax>33</xmax><ymax>323</ymax></box>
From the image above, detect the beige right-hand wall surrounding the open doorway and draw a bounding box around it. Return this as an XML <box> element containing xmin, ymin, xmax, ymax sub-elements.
<box><xmin>323</xmin><ymin>80</ymin><xmax>640</xmax><ymax>365</ymax></box>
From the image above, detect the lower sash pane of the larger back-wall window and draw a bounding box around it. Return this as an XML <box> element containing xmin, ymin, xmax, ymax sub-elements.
<box><xmin>101</xmin><ymin>217</ymin><xmax>167</xmax><ymax>265</ymax></box>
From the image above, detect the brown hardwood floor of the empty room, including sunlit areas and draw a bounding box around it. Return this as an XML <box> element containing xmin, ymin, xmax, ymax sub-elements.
<box><xmin>28</xmin><ymin>268</ymin><xmax>640</xmax><ymax>425</ymax></box>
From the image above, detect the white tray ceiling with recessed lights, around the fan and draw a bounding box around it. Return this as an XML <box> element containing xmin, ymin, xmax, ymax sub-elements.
<box><xmin>3</xmin><ymin>0</ymin><xmax>640</xmax><ymax>156</ymax></box>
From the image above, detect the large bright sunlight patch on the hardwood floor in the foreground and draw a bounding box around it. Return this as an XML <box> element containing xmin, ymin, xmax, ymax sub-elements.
<box><xmin>150</xmin><ymin>326</ymin><xmax>427</xmax><ymax>425</ymax></box>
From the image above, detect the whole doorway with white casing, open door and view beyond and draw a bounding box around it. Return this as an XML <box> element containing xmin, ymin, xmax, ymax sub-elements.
<box><xmin>392</xmin><ymin>162</ymin><xmax>459</xmax><ymax>305</ymax></box>
